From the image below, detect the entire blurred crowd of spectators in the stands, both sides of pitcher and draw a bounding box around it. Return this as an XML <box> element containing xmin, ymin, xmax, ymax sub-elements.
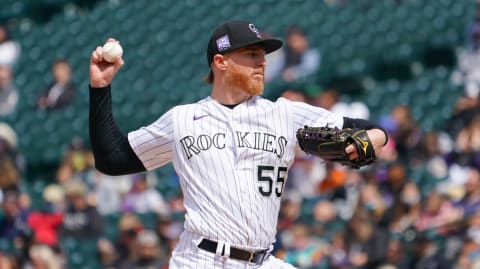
<box><xmin>0</xmin><ymin>1</ymin><xmax>480</xmax><ymax>269</ymax></box>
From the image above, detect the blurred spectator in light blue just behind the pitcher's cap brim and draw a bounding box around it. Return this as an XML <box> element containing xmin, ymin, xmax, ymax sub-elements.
<box><xmin>266</xmin><ymin>26</ymin><xmax>320</xmax><ymax>82</ymax></box>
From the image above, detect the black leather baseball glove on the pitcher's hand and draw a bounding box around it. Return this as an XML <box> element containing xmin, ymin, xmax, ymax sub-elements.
<box><xmin>297</xmin><ymin>126</ymin><xmax>376</xmax><ymax>169</ymax></box>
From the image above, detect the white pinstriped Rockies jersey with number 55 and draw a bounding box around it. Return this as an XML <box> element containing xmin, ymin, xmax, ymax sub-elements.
<box><xmin>128</xmin><ymin>94</ymin><xmax>343</xmax><ymax>250</ymax></box>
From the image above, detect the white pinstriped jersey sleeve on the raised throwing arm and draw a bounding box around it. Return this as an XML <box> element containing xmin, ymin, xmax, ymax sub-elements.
<box><xmin>128</xmin><ymin>109</ymin><xmax>174</xmax><ymax>170</ymax></box>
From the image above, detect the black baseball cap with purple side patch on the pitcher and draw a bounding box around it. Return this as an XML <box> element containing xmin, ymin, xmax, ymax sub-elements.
<box><xmin>207</xmin><ymin>21</ymin><xmax>283</xmax><ymax>66</ymax></box>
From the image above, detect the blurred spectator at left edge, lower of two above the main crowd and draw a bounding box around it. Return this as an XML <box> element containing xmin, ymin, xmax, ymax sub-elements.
<box><xmin>0</xmin><ymin>65</ymin><xmax>18</xmax><ymax>116</ymax></box>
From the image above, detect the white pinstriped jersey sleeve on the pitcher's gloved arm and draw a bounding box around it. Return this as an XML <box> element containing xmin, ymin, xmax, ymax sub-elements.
<box><xmin>292</xmin><ymin>99</ymin><xmax>343</xmax><ymax>130</ymax></box>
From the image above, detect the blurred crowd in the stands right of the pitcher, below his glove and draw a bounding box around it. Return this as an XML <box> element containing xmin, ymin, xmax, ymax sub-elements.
<box><xmin>275</xmin><ymin>87</ymin><xmax>480</xmax><ymax>269</ymax></box>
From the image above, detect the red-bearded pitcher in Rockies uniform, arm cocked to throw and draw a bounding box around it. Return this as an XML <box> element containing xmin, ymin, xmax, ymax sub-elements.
<box><xmin>89</xmin><ymin>21</ymin><xmax>387</xmax><ymax>269</ymax></box>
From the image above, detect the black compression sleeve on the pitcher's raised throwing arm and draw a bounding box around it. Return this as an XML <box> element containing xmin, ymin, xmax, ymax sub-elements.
<box><xmin>89</xmin><ymin>85</ymin><xmax>146</xmax><ymax>175</ymax></box>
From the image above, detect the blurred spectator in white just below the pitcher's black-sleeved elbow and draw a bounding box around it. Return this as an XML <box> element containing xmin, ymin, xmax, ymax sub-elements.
<box><xmin>122</xmin><ymin>173</ymin><xmax>170</xmax><ymax>215</ymax></box>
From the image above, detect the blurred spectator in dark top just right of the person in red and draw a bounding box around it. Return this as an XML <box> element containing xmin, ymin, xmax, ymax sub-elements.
<box><xmin>61</xmin><ymin>180</ymin><xmax>104</xmax><ymax>239</ymax></box>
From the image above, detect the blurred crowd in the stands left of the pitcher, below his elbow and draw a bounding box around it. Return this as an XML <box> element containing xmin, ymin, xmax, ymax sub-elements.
<box><xmin>0</xmin><ymin>128</ymin><xmax>184</xmax><ymax>268</ymax></box>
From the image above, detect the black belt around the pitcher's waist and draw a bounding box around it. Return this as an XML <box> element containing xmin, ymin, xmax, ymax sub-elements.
<box><xmin>198</xmin><ymin>239</ymin><xmax>270</xmax><ymax>264</ymax></box>
